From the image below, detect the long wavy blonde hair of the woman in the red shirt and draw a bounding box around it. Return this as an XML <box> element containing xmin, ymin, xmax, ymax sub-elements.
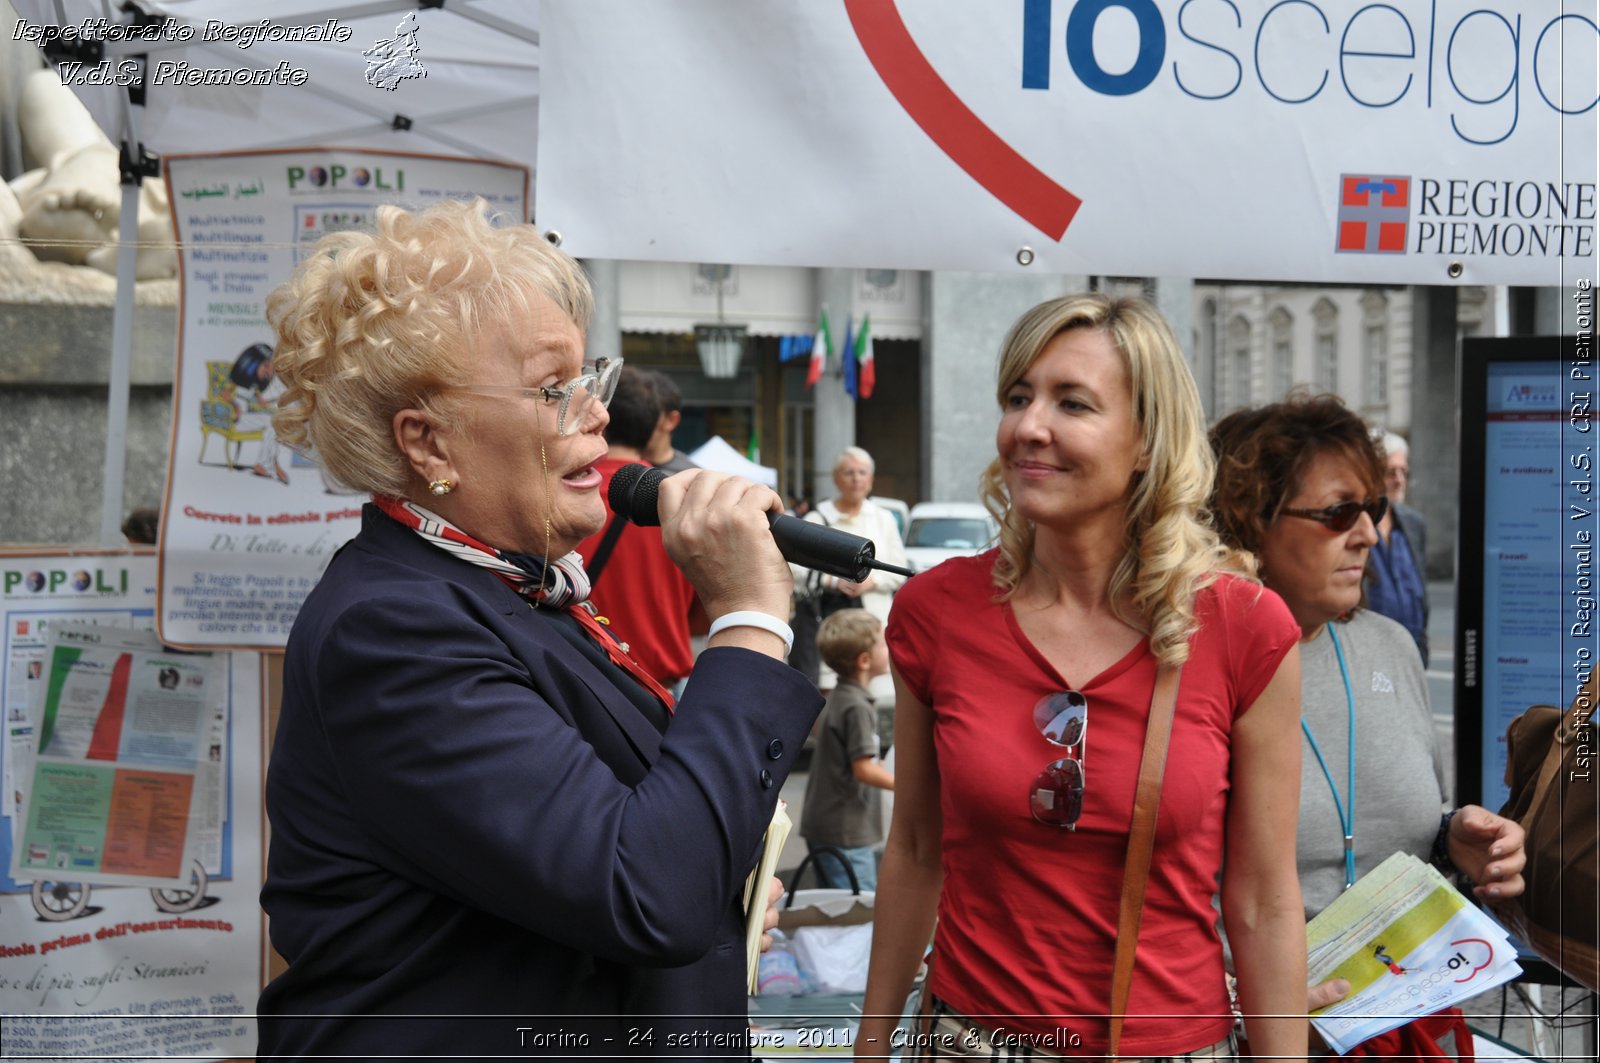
<box><xmin>981</xmin><ymin>293</ymin><xmax>1248</xmax><ymax>664</ymax></box>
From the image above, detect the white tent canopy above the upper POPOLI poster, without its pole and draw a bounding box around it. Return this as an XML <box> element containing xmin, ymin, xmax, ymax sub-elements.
<box><xmin>11</xmin><ymin>0</ymin><xmax>539</xmax><ymax>166</ymax></box>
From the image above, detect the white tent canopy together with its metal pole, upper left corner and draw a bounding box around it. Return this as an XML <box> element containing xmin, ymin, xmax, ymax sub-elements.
<box><xmin>11</xmin><ymin>0</ymin><xmax>539</xmax><ymax>546</ymax></box>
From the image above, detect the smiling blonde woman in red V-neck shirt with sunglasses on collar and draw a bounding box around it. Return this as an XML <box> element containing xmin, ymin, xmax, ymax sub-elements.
<box><xmin>856</xmin><ymin>295</ymin><xmax>1306</xmax><ymax>1058</ymax></box>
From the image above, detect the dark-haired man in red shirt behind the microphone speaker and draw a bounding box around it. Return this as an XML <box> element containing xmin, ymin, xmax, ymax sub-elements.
<box><xmin>578</xmin><ymin>365</ymin><xmax>694</xmax><ymax>693</ymax></box>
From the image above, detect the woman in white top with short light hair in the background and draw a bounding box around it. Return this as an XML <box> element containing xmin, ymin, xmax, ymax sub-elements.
<box><xmin>790</xmin><ymin>447</ymin><xmax>907</xmax><ymax>695</ymax></box>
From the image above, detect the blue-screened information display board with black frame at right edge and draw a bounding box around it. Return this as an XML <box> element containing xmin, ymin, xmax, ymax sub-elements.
<box><xmin>1456</xmin><ymin>328</ymin><xmax>1600</xmax><ymax>808</ymax></box>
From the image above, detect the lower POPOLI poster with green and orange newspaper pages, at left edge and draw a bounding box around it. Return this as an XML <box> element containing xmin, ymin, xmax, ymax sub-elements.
<box><xmin>0</xmin><ymin>551</ymin><xmax>264</xmax><ymax>1058</ymax></box>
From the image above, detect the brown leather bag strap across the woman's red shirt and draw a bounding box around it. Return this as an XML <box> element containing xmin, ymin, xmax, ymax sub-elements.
<box><xmin>1109</xmin><ymin>664</ymin><xmax>1182</xmax><ymax>1060</ymax></box>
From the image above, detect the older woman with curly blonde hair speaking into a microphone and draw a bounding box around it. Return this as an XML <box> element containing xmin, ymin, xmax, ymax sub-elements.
<box><xmin>259</xmin><ymin>202</ymin><xmax>821</xmax><ymax>1058</ymax></box>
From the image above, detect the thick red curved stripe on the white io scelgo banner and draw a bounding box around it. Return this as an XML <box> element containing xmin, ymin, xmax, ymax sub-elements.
<box><xmin>845</xmin><ymin>0</ymin><xmax>1083</xmax><ymax>240</ymax></box>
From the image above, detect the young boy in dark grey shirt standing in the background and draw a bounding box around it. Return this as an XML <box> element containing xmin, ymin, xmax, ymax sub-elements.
<box><xmin>800</xmin><ymin>608</ymin><xmax>894</xmax><ymax>890</ymax></box>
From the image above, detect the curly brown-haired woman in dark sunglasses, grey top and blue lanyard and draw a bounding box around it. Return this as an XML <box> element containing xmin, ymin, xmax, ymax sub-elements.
<box><xmin>1211</xmin><ymin>394</ymin><xmax>1525</xmax><ymax>1056</ymax></box>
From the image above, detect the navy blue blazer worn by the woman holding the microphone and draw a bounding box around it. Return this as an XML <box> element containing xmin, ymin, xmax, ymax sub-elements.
<box><xmin>258</xmin><ymin>506</ymin><xmax>822</xmax><ymax>1058</ymax></box>
